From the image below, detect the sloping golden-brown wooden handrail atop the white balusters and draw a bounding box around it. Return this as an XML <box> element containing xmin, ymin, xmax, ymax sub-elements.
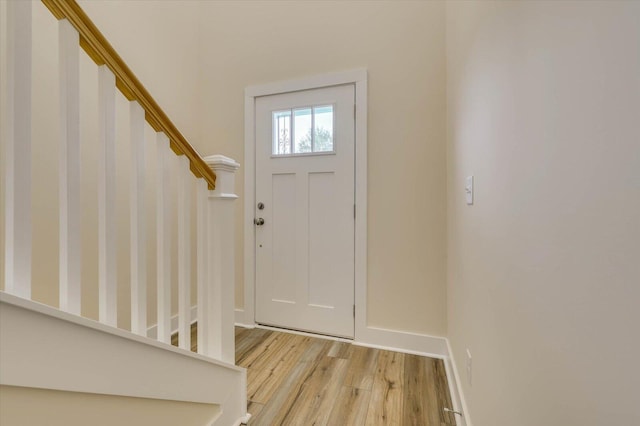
<box><xmin>42</xmin><ymin>0</ymin><xmax>216</xmax><ymax>189</ymax></box>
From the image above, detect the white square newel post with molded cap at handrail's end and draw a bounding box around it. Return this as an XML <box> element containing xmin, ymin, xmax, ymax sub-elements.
<box><xmin>204</xmin><ymin>155</ymin><xmax>240</xmax><ymax>364</ymax></box>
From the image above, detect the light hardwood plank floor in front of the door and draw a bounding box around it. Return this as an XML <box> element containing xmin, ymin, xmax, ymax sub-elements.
<box><xmin>172</xmin><ymin>328</ymin><xmax>455</xmax><ymax>426</ymax></box>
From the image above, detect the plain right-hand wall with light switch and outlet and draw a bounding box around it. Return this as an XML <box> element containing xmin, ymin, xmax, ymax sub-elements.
<box><xmin>447</xmin><ymin>1</ymin><xmax>640</xmax><ymax>426</ymax></box>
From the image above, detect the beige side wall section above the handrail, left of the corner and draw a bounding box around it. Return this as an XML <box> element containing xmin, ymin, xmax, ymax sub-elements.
<box><xmin>78</xmin><ymin>0</ymin><xmax>201</xmax><ymax>146</ymax></box>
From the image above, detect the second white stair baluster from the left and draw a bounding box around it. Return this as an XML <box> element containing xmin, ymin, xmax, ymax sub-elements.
<box><xmin>57</xmin><ymin>19</ymin><xmax>81</xmax><ymax>315</ymax></box>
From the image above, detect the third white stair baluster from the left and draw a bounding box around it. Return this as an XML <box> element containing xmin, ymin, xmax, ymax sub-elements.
<box><xmin>98</xmin><ymin>65</ymin><xmax>118</xmax><ymax>327</ymax></box>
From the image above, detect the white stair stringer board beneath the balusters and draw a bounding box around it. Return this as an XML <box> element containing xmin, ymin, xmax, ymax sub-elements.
<box><xmin>0</xmin><ymin>292</ymin><xmax>247</xmax><ymax>426</ymax></box>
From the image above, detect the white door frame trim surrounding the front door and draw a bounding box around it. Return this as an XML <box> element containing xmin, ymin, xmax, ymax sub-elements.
<box><xmin>242</xmin><ymin>69</ymin><xmax>367</xmax><ymax>340</ymax></box>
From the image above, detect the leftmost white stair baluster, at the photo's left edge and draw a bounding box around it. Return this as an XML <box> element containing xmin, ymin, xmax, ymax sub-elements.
<box><xmin>0</xmin><ymin>1</ymin><xmax>31</xmax><ymax>299</ymax></box>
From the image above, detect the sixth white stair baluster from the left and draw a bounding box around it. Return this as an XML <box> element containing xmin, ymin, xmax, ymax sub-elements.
<box><xmin>178</xmin><ymin>155</ymin><xmax>193</xmax><ymax>350</ymax></box>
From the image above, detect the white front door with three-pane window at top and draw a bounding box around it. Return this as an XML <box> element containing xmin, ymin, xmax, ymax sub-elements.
<box><xmin>255</xmin><ymin>84</ymin><xmax>355</xmax><ymax>338</ymax></box>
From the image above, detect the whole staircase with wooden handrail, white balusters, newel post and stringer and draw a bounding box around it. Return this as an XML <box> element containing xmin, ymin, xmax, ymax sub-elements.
<box><xmin>0</xmin><ymin>0</ymin><xmax>248</xmax><ymax>426</ymax></box>
